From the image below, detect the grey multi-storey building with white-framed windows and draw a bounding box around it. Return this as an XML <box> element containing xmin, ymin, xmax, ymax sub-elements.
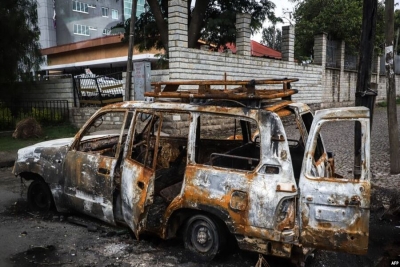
<box><xmin>38</xmin><ymin>0</ymin><xmax>132</xmax><ymax>48</ymax></box>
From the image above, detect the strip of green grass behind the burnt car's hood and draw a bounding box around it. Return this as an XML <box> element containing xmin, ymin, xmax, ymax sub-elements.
<box><xmin>0</xmin><ymin>125</ymin><xmax>78</xmax><ymax>151</ymax></box>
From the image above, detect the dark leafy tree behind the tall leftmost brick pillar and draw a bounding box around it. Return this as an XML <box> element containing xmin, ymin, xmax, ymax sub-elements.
<box><xmin>120</xmin><ymin>0</ymin><xmax>279</xmax><ymax>51</ymax></box>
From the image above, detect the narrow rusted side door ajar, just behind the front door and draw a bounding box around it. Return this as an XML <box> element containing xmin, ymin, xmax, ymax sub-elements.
<box><xmin>121</xmin><ymin>111</ymin><xmax>161</xmax><ymax>238</ymax></box>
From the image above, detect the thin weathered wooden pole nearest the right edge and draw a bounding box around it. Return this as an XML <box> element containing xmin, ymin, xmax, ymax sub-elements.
<box><xmin>385</xmin><ymin>0</ymin><xmax>400</xmax><ymax>174</ymax></box>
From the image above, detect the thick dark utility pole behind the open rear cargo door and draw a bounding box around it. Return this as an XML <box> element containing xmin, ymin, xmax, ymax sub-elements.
<box><xmin>354</xmin><ymin>0</ymin><xmax>378</xmax><ymax>179</ymax></box>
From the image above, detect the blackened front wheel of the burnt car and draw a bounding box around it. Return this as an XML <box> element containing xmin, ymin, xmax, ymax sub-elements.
<box><xmin>28</xmin><ymin>180</ymin><xmax>53</xmax><ymax>212</ymax></box>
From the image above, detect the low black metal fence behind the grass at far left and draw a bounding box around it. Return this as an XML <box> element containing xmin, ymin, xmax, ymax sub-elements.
<box><xmin>0</xmin><ymin>100</ymin><xmax>69</xmax><ymax>130</ymax></box>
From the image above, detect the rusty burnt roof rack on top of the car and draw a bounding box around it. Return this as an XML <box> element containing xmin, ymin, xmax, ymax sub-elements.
<box><xmin>144</xmin><ymin>78</ymin><xmax>299</xmax><ymax>107</ymax></box>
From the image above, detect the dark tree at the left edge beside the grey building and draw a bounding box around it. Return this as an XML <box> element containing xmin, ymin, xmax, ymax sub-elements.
<box><xmin>0</xmin><ymin>0</ymin><xmax>43</xmax><ymax>103</ymax></box>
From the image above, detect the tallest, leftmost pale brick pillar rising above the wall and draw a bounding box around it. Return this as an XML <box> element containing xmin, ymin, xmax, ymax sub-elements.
<box><xmin>168</xmin><ymin>0</ymin><xmax>188</xmax><ymax>51</ymax></box>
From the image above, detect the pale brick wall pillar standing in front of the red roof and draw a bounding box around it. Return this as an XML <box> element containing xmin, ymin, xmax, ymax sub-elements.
<box><xmin>236</xmin><ymin>13</ymin><xmax>251</xmax><ymax>56</ymax></box>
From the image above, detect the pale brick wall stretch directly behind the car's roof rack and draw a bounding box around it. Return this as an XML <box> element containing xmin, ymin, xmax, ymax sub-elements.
<box><xmin>169</xmin><ymin>48</ymin><xmax>323</xmax><ymax>103</ymax></box>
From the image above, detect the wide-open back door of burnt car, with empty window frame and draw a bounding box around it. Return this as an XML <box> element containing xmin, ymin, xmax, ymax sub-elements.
<box><xmin>299</xmin><ymin>107</ymin><xmax>371</xmax><ymax>254</ymax></box>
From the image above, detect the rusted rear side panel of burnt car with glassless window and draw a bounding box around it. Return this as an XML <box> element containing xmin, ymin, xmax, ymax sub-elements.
<box><xmin>185</xmin><ymin>109</ymin><xmax>297</xmax><ymax>255</ymax></box>
